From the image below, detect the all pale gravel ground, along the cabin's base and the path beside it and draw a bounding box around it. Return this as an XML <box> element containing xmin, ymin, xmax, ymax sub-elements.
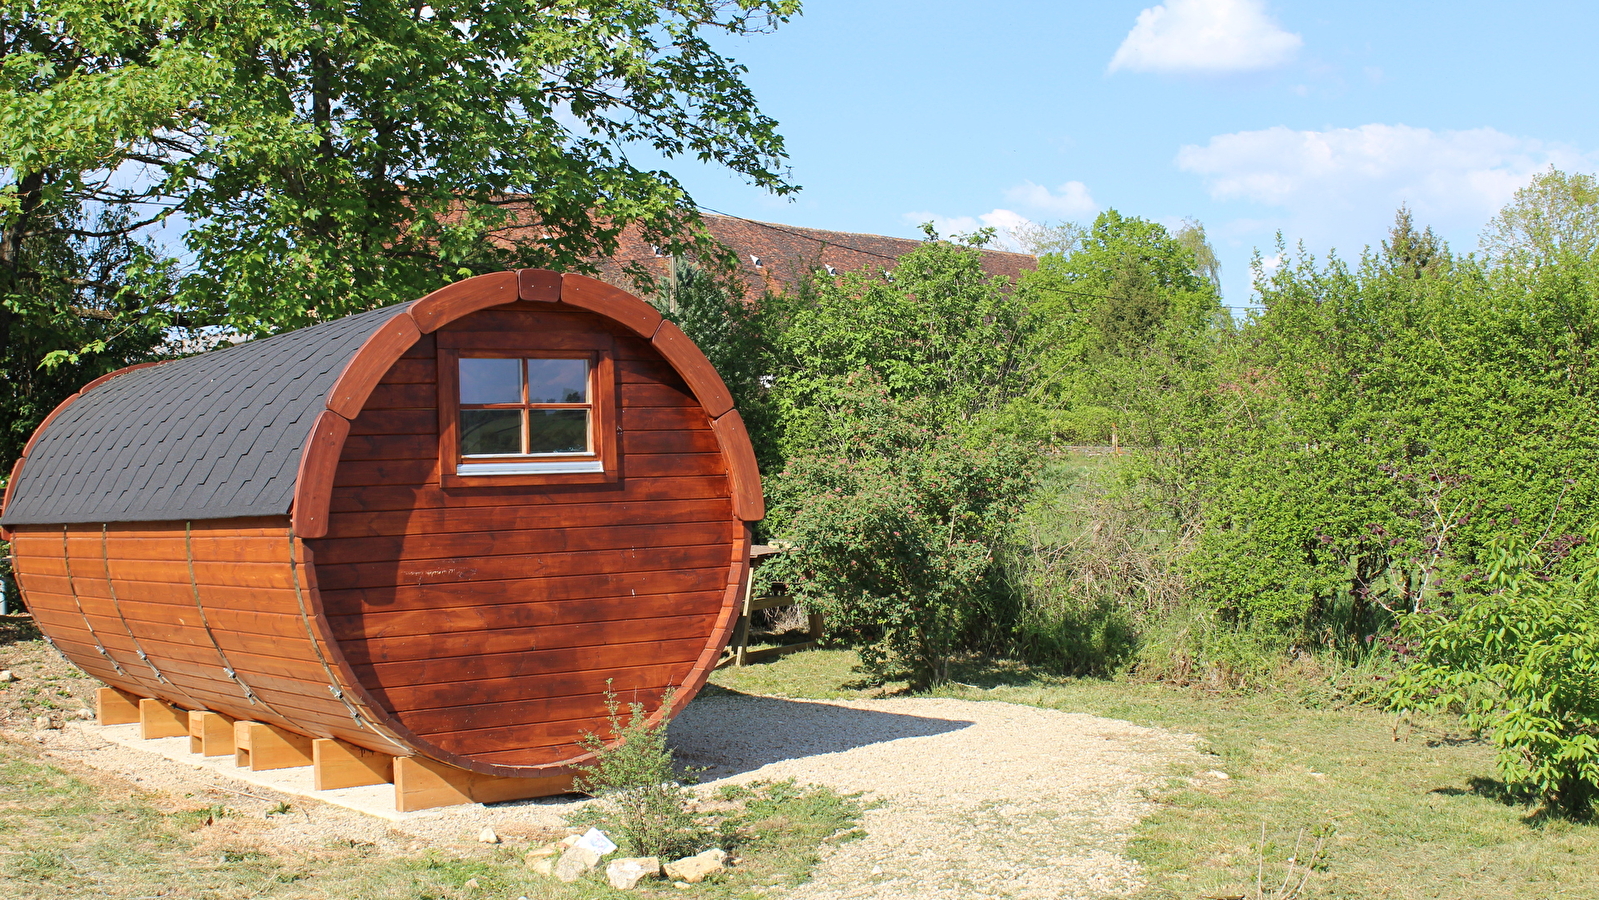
<box><xmin>0</xmin><ymin>626</ymin><xmax>1199</xmax><ymax>900</ymax></box>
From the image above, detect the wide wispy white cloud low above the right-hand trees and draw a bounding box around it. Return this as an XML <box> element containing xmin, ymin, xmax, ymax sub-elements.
<box><xmin>1177</xmin><ymin>125</ymin><xmax>1591</xmax><ymax>224</ymax></box>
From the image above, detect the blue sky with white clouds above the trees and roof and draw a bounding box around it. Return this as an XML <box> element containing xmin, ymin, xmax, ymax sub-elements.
<box><xmin>668</xmin><ymin>0</ymin><xmax>1599</xmax><ymax>305</ymax></box>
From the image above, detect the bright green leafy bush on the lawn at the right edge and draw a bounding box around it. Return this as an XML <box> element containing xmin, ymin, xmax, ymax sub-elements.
<box><xmin>1390</xmin><ymin>529</ymin><xmax>1599</xmax><ymax>817</ymax></box>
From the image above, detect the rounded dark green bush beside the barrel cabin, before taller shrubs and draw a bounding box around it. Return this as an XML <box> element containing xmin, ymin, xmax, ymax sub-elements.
<box><xmin>763</xmin><ymin>377</ymin><xmax>1035</xmax><ymax>687</ymax></box>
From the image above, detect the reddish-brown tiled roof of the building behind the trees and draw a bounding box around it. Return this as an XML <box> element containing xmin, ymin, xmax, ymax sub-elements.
<box><xmin>600</xmin><ymin>214</ymin><xmax>1038</xmax><ymax>296</ymax></box>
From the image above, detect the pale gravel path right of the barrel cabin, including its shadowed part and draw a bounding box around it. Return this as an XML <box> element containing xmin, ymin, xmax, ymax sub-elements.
<box><xmin>672</xmin><ymin>695</ymin><xmax>1199</xmax><ymax>900</ymax></box>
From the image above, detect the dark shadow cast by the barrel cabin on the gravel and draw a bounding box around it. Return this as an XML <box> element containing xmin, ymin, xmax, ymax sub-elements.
<box><xmin>668</xmin><ymin>691</ymin><xmax>972</xmax><ymax>780</ymax></box>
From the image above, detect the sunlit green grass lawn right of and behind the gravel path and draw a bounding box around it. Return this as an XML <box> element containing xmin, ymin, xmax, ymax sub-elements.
<box><xmin>713</xmin><ymin>651</ymin><xmax>1599</xmax><ymax>900</ymax></box>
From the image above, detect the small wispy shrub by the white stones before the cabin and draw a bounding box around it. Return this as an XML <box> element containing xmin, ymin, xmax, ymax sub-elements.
<box><xmin>572</xmin><ymin>691</ymin><xmax>707</xmax><ymax>858</ymax></box>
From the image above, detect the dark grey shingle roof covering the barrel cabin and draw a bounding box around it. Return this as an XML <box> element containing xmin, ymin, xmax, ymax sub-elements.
<box><xmin>0</xmin><ymin>304</ymin><xmax>409</xmax><ymax>526</ymax></box>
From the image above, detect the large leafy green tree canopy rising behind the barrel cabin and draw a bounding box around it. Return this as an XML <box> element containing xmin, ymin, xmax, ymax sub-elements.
<box><xmin>0</xmin><ymin>0</ymin><xmax>800</xmax><ymax>460</ymax></box>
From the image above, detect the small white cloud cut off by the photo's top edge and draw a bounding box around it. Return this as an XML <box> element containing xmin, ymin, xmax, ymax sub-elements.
<box><xmin>1108</xmin><ymin>0</ymin><xmax>1305</xmax><ymax>74</ymax></box>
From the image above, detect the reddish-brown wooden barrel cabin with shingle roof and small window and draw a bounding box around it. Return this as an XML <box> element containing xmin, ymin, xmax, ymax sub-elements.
<box><xmin>0</xmin><ymin>270</ymin><xmax>763</xmax><ymax>809</ymax></box>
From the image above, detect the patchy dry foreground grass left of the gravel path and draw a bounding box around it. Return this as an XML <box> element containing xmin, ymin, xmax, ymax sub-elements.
<box><xmin>0</xmin><ymin>706</ymin><xmax>860</xmax><ymax>900</ymax></box>
